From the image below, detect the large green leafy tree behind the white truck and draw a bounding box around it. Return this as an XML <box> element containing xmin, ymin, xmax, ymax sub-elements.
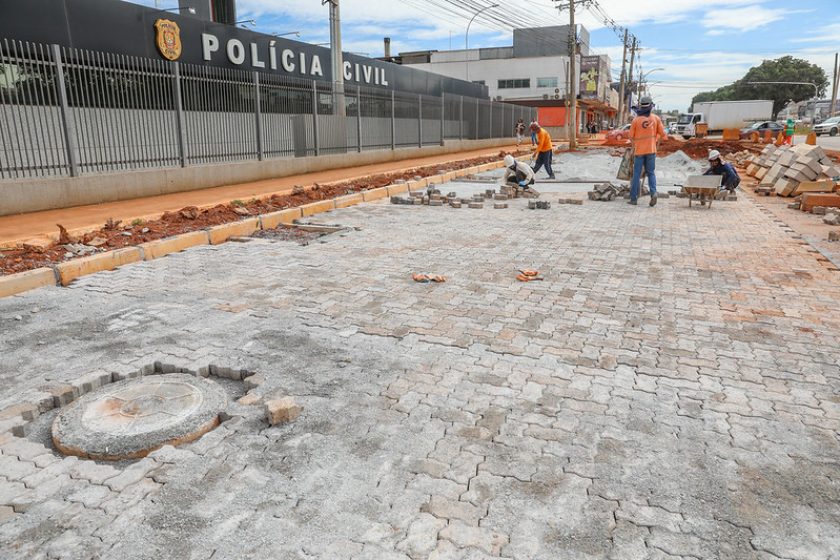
<box><xmin>691</xmin><ymin>56</ymin><xmax>828</xmax><ymax>117</ymax></box>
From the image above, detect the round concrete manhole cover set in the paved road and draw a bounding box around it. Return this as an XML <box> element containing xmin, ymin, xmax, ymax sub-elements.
<box><xmin>52</xmin><ymin>373</ymin><xmax>227</xmax><ymax>460</ymax></box>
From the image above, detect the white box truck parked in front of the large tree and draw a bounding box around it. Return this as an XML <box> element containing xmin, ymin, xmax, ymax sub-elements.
<box><xmin>677</xmin><ymin>100</ymin><xmax>773</xmax><ymax>140</ymax></box>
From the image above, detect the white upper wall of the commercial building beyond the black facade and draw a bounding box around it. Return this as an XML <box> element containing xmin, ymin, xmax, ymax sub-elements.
<box><xmin>411</xmin><ymin>55</ymin><xmax>580</xmax><ymax>100</ymax></box>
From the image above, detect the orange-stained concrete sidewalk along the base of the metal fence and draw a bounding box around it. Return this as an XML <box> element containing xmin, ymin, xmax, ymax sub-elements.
<box><xmin>0</xmin><ymin>144</ymin><xmax>516</xmax><ymax>247</ymax></box>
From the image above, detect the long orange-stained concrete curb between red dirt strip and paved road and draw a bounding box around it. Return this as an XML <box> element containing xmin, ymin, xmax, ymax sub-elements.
<box><xmin>0</xmin><ymin>155</ymin><xmax>503</xmax><ymax>298</ymax></box>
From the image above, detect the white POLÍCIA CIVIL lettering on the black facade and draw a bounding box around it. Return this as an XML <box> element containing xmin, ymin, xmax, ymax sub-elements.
<box><xmin>201</xmin><ymin>33</ymin><xmax>389</xmax><ymax>86</ymax></box>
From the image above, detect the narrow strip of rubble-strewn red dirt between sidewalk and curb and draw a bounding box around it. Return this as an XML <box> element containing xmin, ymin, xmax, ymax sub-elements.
<box><xmin>0</xmin><ymin>151</ymin><xmax>527</xmax><ymax>276</ymax></box>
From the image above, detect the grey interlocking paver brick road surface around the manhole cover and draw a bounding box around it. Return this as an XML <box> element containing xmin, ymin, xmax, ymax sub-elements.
<box><xmin>0</xmin><ymin>182</ymin><xmax>840</xmax><ymax>560</ymax></box>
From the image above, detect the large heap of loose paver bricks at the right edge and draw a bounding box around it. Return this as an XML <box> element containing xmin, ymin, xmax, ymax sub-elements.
<box><xmin>747</xmin><ymin>144</ymin><xmax>840</xmax><ymax>196</ymax></box>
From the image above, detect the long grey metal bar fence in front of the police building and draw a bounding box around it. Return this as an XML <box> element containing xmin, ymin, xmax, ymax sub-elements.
<box><xmin>0</xmin><ymin>40</ymin><xmax>533</xmax><ymax>179</ymax></box>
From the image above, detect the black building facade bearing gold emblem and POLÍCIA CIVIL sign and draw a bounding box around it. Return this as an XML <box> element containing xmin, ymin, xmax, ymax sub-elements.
<box><xmin>0</xmin><ymin>0</ymin><xmax>488</xmax><ymax>99</ymax></box>
